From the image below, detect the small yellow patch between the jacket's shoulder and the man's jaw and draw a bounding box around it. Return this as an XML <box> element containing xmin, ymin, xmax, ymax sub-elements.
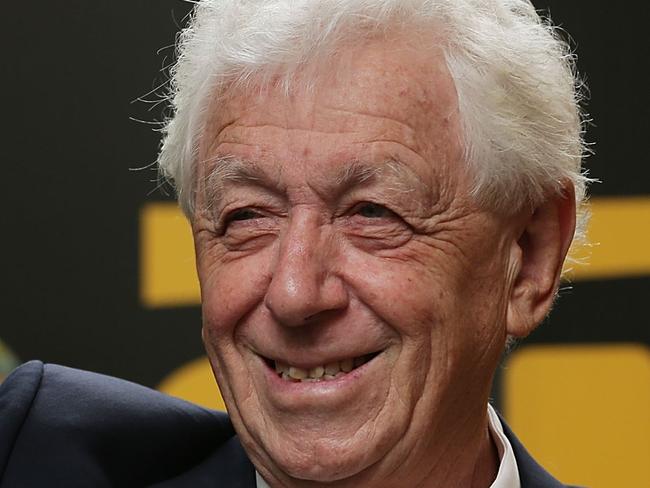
<box><xmin>158</xmin><ymin>357</ymin><xmax>226</xmax><ymax>412</ymax></box>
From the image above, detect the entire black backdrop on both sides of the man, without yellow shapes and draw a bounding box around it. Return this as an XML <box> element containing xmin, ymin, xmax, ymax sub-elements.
<box><xmin>0</xmin><ymin>0</ymin><xmax>650</xmax><ymax>386</ymax></box>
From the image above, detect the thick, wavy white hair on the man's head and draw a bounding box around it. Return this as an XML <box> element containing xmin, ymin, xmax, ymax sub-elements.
<box><xmin>158</xmin><ymin>0</ymin><xmax>587</xmax><ymax>236</ymax></box>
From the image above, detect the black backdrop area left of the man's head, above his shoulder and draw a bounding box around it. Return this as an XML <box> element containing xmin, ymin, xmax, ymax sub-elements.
<box><xmin>0</xmin><ymin>0</ymin><xmax>200</xmax><ymax>385</ymax></box>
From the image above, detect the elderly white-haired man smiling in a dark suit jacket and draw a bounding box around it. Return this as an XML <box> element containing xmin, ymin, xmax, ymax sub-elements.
<box><xmin>0</xmin><ymin>0</ymin><xmax>585</xmax><ymax>488</ymax></box>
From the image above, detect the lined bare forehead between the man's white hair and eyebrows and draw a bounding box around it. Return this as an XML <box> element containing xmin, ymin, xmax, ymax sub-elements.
<box><xmin>199</xmin><ymin>32</ymin><xmax>461</xmax><ymax>191</ymax></box>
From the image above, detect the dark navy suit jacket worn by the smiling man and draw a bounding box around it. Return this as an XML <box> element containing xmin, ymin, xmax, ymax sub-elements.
<box><xmin>0</xmin><ymin>361</ymin><xmax>564</xmax><ymax>488</ymax></box>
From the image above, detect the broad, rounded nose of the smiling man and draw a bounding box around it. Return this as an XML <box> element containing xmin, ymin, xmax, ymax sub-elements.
<box><xmin>265</xmin><ymin>215</ymin><xmax>349</xmax><ymax>327</ymax></box>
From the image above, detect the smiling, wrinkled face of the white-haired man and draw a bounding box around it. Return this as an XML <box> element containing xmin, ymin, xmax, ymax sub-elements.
<box><xmin>193</xmin><ymin>39</ymin><xmax>521</xmax><ymax>486</ymax></box>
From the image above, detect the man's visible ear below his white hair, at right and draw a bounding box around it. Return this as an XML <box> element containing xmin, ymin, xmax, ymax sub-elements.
<box><xmin>506</xmin><ymin>182</ymin><xmax>576</xmax><ymax>337</ymax></box>
